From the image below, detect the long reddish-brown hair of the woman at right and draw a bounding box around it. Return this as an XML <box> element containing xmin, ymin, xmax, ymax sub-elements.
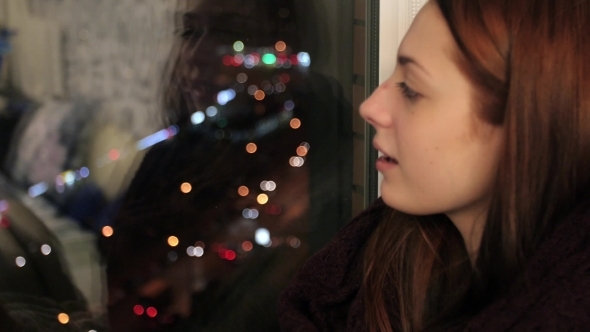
<box><xmin>361</xmin><ymin>0</ymin><xmax>590</xmax><ymax>332</ymax></box>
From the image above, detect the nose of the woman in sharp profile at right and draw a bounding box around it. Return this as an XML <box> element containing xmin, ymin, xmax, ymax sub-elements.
<box><xmin>359</xmin><ymin>84</ymin><xmax>393</xmax><ymax>129</ymax></box>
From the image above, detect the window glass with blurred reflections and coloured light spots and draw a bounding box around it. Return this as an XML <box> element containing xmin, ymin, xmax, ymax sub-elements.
<box><xmin>0</xmin><ymin>0</ymin><xmax>358</xmax><ymax>332</ymax></box>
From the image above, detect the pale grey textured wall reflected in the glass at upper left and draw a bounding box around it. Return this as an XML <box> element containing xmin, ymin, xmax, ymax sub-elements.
<box><xmin>29</xmin><ymin>0</ymin><xmax>176</xmax><ymax>136</ymax></box>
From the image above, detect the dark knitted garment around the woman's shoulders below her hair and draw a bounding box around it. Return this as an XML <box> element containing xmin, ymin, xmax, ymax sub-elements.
<box><xmin>279</xmin><ymin>200</ymin><xmax>590</xmax><ymax>332</ymax></box>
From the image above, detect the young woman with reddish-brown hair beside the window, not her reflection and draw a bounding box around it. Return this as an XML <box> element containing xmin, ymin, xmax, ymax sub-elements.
<box><xmin>279</xmin><ymin>0</ymin><xmax>590</xmax><ymax>332</ymax></box>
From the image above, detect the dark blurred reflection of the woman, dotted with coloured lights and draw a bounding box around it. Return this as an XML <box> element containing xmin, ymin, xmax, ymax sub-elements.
<box><xmin>105</xmin><ymin>0</ymin><xmax>351</xmax><ymax>332</ymax></box>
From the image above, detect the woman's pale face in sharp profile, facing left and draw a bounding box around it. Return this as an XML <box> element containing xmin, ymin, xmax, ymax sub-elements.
<box><xmin>360</xmin><ymin>2</ymin><xmax>503</xmax><ymax>221</ymax></box>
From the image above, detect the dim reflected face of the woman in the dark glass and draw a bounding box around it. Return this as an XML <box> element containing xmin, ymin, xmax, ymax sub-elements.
<box><xmin>177</xmin><ymin>0</ymin><xmax>284</xmax><ymax>110</ymax></box>
